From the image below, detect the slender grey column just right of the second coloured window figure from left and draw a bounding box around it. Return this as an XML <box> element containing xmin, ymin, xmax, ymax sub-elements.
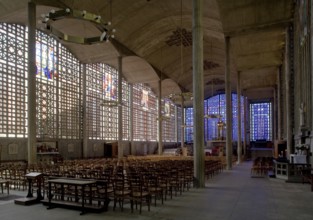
<box><xmin>117</xmin><ymin>56</ymin><xmax>124</xmax><ymax>159</ymax></box>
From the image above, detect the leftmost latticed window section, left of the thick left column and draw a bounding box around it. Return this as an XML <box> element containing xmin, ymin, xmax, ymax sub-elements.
<box><xmin>0</xmin><ymin>23</ymin><xmax>27</xmax><ymax>137</ymax></box>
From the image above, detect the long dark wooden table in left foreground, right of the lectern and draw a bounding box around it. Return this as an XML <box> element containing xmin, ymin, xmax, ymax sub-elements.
<box><xmin>48</xmin><ymin>178</ymin><xmax>97</xmax><ymax>215</ymax></box>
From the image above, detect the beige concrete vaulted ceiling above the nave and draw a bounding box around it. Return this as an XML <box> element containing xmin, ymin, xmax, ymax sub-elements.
<box><xmin>0</xmin><ymin>0</ymin><xmax>294</xmax><ymax>104</ymax></box>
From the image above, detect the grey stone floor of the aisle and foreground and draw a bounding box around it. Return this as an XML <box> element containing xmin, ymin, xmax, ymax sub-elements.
<box><xmin>0</xmin><ymin>162</ymin><xmax>313</xmax><ymax>220</ymax></box>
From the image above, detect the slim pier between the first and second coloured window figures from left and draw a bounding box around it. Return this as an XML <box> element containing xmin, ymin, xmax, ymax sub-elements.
<box><xmin>82</xmin><ymin>64</ymin><xmax>88</xmax><ymax>158</ymax></box>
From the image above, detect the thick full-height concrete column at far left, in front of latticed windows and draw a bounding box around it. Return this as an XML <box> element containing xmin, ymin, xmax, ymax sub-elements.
<box><xmin>27</xmin><ymin>2</ymin><xmax>37</xmax><ymax>164</ymax></box>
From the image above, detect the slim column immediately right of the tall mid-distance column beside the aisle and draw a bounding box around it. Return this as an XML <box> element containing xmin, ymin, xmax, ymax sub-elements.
<box><xmin>237</xmin><ymin>72</ymin><xmax>242</xmax><ymax>163</ymax></box>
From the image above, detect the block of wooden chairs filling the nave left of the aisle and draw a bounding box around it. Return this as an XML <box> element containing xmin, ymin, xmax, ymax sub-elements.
<box><xmin>0</xmin><ymin>157</ymin><xmax>223</xmax><ymax>212</ymax></box>
